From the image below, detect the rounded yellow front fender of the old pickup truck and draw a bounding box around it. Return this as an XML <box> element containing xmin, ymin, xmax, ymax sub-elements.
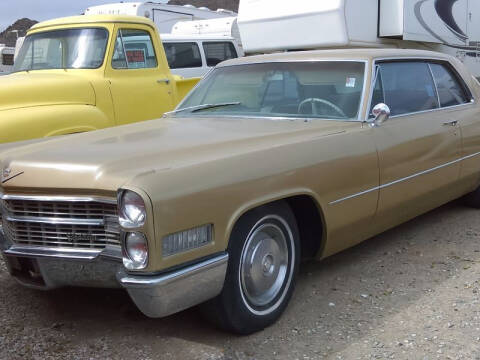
<box><xmin>0</xmin><ymin>105</ymin><xmax>115</xmax><ymax>143</ymax></box>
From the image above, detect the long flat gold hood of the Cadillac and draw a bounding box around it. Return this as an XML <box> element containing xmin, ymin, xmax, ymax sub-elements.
<box><xmin>0</xmin><ymin>118</ymin><xmax>346</xmax><ymax>193</ymax></box>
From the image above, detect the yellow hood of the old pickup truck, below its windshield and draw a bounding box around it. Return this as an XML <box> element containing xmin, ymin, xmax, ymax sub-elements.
<box><xmin>0</xmin><ymin>71</ymin><xmax>95</xmax><ymax>111</ymax></box>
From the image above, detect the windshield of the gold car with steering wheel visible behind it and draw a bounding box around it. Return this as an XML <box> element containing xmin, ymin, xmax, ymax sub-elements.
<box><xmin>174</xmin><ymin>61</ymin><xmax>365</xmax><ymax>120</ymax></box>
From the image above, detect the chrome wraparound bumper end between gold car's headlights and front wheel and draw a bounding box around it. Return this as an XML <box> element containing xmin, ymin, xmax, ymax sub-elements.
<box><xmin>117</xmin><ymin>253</ymin><xmax>228</xmax><ymax>318</ymax></box>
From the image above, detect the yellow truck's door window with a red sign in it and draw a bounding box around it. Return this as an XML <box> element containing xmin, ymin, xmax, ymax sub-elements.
<box><xmin>112</xmin><ymin>29</ymin><xmax>158</xmax><ymax>69</ymax></box>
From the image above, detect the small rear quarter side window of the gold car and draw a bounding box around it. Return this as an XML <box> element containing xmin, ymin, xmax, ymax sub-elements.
<box><xmin>430</xmin><ymin>64</ymin><xmax>468</xmax><ymax>107</ymax></box>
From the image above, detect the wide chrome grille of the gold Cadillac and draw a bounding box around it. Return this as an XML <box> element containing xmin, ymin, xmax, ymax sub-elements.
<box><xmin>0</xmin><ymin>198</ymin><xmax>120</xmax><ymax>249</ymax></box>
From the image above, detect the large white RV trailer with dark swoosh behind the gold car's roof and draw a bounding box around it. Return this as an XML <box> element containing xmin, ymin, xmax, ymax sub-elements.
<box><xmin>238</xmin><ymin>0</ymin><xmax>480</xmax><ymax>77</ymax></box>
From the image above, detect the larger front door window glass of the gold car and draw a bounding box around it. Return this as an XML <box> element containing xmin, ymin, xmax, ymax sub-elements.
<box><xmin>379</xmin><ymin>62</ymin><xmax>439</xmax><ymax>116</ymax></box>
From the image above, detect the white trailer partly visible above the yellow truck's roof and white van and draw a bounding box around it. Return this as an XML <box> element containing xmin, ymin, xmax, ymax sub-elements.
<box><xmin>85</xmin><ymin>0</ymin><xmax>237</xmax><ymax>33</ymax></box>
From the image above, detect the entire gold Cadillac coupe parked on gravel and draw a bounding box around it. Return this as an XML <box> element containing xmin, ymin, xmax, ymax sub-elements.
<box><xmin>0</xmin><ymin>49</ymin><xmax>480</xmax><ymax>334</ymax></box>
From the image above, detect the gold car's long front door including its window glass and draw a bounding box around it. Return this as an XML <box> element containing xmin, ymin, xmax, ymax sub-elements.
<box><xmin>372</xmin><ymin>61</ymin><xmax>461</xmax><ymax>231</ymax></box>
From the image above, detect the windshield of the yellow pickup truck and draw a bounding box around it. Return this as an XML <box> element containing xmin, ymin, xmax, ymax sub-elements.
<box><xmin>14</xmin><ymin>29</ymin><xmax>108</xmax><ymax>71</ymax></box>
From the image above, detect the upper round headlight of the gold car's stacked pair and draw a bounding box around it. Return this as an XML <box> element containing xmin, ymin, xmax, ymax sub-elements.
<box><xmin>119</xmin><ymin>190</ymin><xmax>147</xmax><ymax>229</ymax></box>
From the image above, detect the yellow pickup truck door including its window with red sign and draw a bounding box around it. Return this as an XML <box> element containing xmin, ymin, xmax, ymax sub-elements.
<box><xmin>106</xmin><ymin>24</ymin><xmax>174</xmax><ymax>125</ymax></box>
